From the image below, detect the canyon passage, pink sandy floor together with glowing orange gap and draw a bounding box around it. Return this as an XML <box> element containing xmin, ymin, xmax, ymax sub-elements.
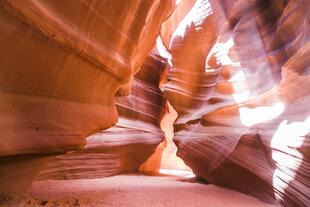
<box><xmin>0</xmin><ymin>102</ymin><xmax>276</xmax><ymax>207</ymax></box>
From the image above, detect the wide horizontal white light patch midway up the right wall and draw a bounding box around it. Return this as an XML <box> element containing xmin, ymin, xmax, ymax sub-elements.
<box><xmin>239</xmin><ymin>102</ymin><xmax>284</xmax><ymax>126</ymax></box>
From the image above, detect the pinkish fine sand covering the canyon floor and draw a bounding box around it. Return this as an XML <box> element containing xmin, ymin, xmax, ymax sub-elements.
<box><xmin>7</xmin><ymin>174</ymin><xmax>280</xmax><ymax>207</ymax></box>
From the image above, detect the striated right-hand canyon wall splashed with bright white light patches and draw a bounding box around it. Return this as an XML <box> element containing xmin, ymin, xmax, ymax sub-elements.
<box><xmin>162</xmin><ymin>0</ymin><xmax>310</xmax><ymax>206</ymax></box>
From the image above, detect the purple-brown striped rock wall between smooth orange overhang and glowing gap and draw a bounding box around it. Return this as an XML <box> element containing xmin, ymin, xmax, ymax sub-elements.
<box><xmin>37</xmin><ymin>55</ymin><xmax>166</xmax><ymax>179</ymax></box>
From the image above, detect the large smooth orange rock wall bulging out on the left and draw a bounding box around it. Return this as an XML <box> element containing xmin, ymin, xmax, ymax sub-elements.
<box><xmin>0</xmin><ymin>0</ymin><xmax>172</xmax><ymax>191</ymax></box>
